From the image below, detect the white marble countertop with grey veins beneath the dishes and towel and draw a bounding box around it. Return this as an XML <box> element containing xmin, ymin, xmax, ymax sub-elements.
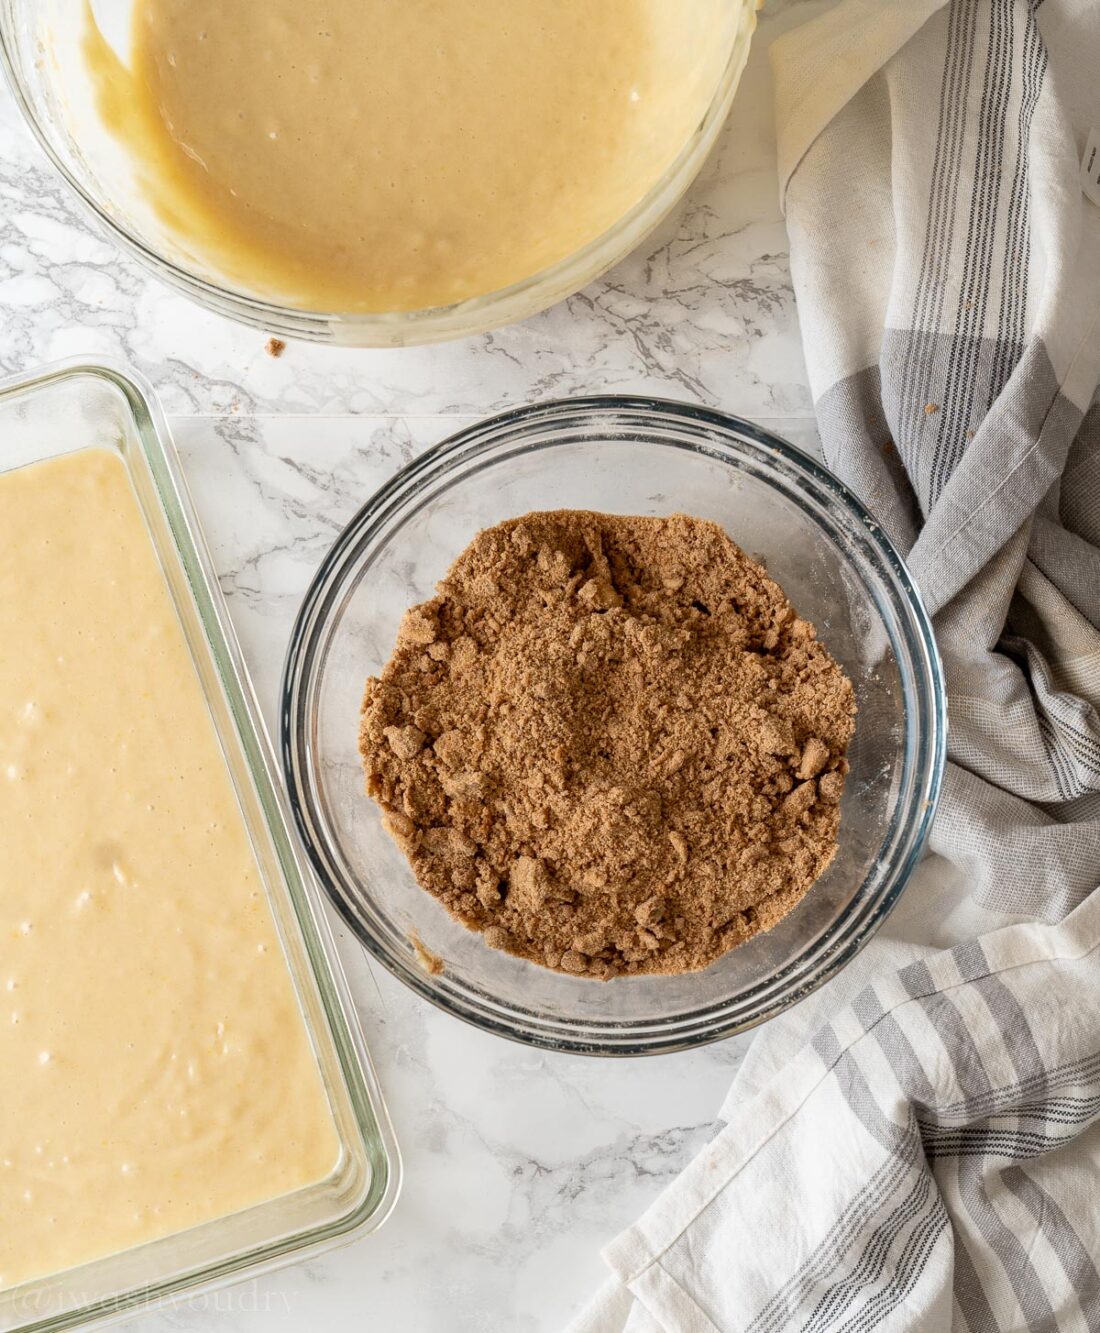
<box><xmin>0</xmin><ymin>0</ymin><xmax>813</xmax><ymax>1333</ymax></box>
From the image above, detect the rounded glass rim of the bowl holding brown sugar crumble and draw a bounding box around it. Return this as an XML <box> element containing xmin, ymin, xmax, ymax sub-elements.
<box><xmin>279</xmin><ymin>395</ymin><xmax>947</xmax><ymax>1056</ymax></box>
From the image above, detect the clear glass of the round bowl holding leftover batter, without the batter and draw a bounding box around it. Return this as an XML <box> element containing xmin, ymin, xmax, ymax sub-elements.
<box><xmin>0</xmin><ymin>0</ymin><xmax>756</xmax><ymax>347</ymax></box>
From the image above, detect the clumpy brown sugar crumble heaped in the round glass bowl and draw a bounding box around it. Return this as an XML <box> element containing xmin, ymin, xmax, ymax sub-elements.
<box><xmin>359</xmin><ymin>511</ymin><xmax>855</xmax><ymax>978</ymax></box>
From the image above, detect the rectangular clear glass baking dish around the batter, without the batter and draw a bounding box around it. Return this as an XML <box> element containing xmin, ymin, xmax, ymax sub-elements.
<box><xmin>0</xmin><ymin>363</ymin><xmax>400</xmax><ymax>1333</ymax></box>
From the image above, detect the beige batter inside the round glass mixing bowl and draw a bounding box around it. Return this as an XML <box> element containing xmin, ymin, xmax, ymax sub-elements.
<box><xmin>87</xmin><ymin>0</ymin><xmax>735</xmax><ymax>312</ymax></box>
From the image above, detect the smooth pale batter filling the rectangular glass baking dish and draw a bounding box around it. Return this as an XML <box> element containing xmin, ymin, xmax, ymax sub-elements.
<box><xmin>0</xmin><ymin>451</ymin><xmax>339</xmax><ymax>1288</ymax></box>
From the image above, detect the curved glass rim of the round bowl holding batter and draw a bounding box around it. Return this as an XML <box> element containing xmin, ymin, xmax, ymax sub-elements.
<box><xmin>0</xmin><ymin>0</ymin><xmax>757</xmax><ymax>347</ymax></box>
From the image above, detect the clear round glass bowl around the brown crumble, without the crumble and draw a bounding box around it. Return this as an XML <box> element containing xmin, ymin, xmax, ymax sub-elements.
<box><xmin>281</xmin><ymin>397</ymin><xmax>945</xmax><ymax>1054</ymax></box>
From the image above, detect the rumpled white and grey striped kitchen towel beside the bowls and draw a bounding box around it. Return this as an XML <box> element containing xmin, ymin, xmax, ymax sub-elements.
<box><xmin>572</xmin><ymin>0</ymin><xmax>1100</xmax><ymax>1333</ymax></box>
